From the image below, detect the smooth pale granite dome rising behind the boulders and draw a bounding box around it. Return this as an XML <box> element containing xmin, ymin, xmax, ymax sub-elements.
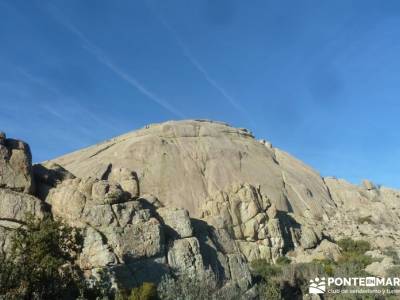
<box><xmin>50</xmin><ymin>121</ymin><xmax>334</xmax><ymax>218</ymax></box>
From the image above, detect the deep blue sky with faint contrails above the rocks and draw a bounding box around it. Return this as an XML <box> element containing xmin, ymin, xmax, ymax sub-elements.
<box><xmin>0</xmin><ymin>0</ymin><xmax>400</xmax><ymax>188</ymax></box>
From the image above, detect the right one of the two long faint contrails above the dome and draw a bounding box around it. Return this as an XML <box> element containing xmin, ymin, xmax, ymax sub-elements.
<box><xmin>153</xmin><ymin>10</ymin><xmax>253</xmax><ymax>123</ymax></box>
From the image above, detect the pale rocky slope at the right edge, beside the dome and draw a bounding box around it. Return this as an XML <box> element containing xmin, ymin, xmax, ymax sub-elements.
<box><xmin>325</xmin><ymin>178</ymin><xmax>400</xmax><ymax>248</ymax></box>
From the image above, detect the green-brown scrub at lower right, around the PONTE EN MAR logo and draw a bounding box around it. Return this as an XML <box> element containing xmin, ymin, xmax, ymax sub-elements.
<box><xmin>251</xmin><ymin>239</ymin><xmax>382</xmax><ymax>299</ymax></box>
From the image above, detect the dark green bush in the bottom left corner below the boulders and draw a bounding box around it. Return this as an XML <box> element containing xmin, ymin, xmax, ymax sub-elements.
<box><xmin>0</xmin><ymin>215</ymin><xmax>87</xmax><ymax>299</ymax></box>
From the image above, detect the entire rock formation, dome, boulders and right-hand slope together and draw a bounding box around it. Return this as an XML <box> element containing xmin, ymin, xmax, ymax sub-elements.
<box><xmin>0</xmin><ymin>121</ymin><xmax>400</xmax><ymax>293</ymax></box>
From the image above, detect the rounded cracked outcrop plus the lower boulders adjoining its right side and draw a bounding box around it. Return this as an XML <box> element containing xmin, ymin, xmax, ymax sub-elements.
<box><xmin>203</xmin><ymin>183</ymin><xmax>327</xmax><ymax>262</ymax></box>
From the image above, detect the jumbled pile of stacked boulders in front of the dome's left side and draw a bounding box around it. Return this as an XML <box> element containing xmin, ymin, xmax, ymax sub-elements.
<box><xmin>34</xmin><ymin>159</ymin><xmax>251</xmax><ymax>292</ymax></box>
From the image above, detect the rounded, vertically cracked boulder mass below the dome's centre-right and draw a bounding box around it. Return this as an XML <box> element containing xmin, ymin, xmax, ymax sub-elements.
<box><xmin>202</xmin><ymin>183</ymin><xmax>291</xmax><ymax>262</ymax></box>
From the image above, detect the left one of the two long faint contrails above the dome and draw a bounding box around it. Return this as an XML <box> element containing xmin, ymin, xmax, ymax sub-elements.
<box><xmin>47</xmin><ymin>9</ymin><xmax>186</xmax><ymax>119</ymax></box>
